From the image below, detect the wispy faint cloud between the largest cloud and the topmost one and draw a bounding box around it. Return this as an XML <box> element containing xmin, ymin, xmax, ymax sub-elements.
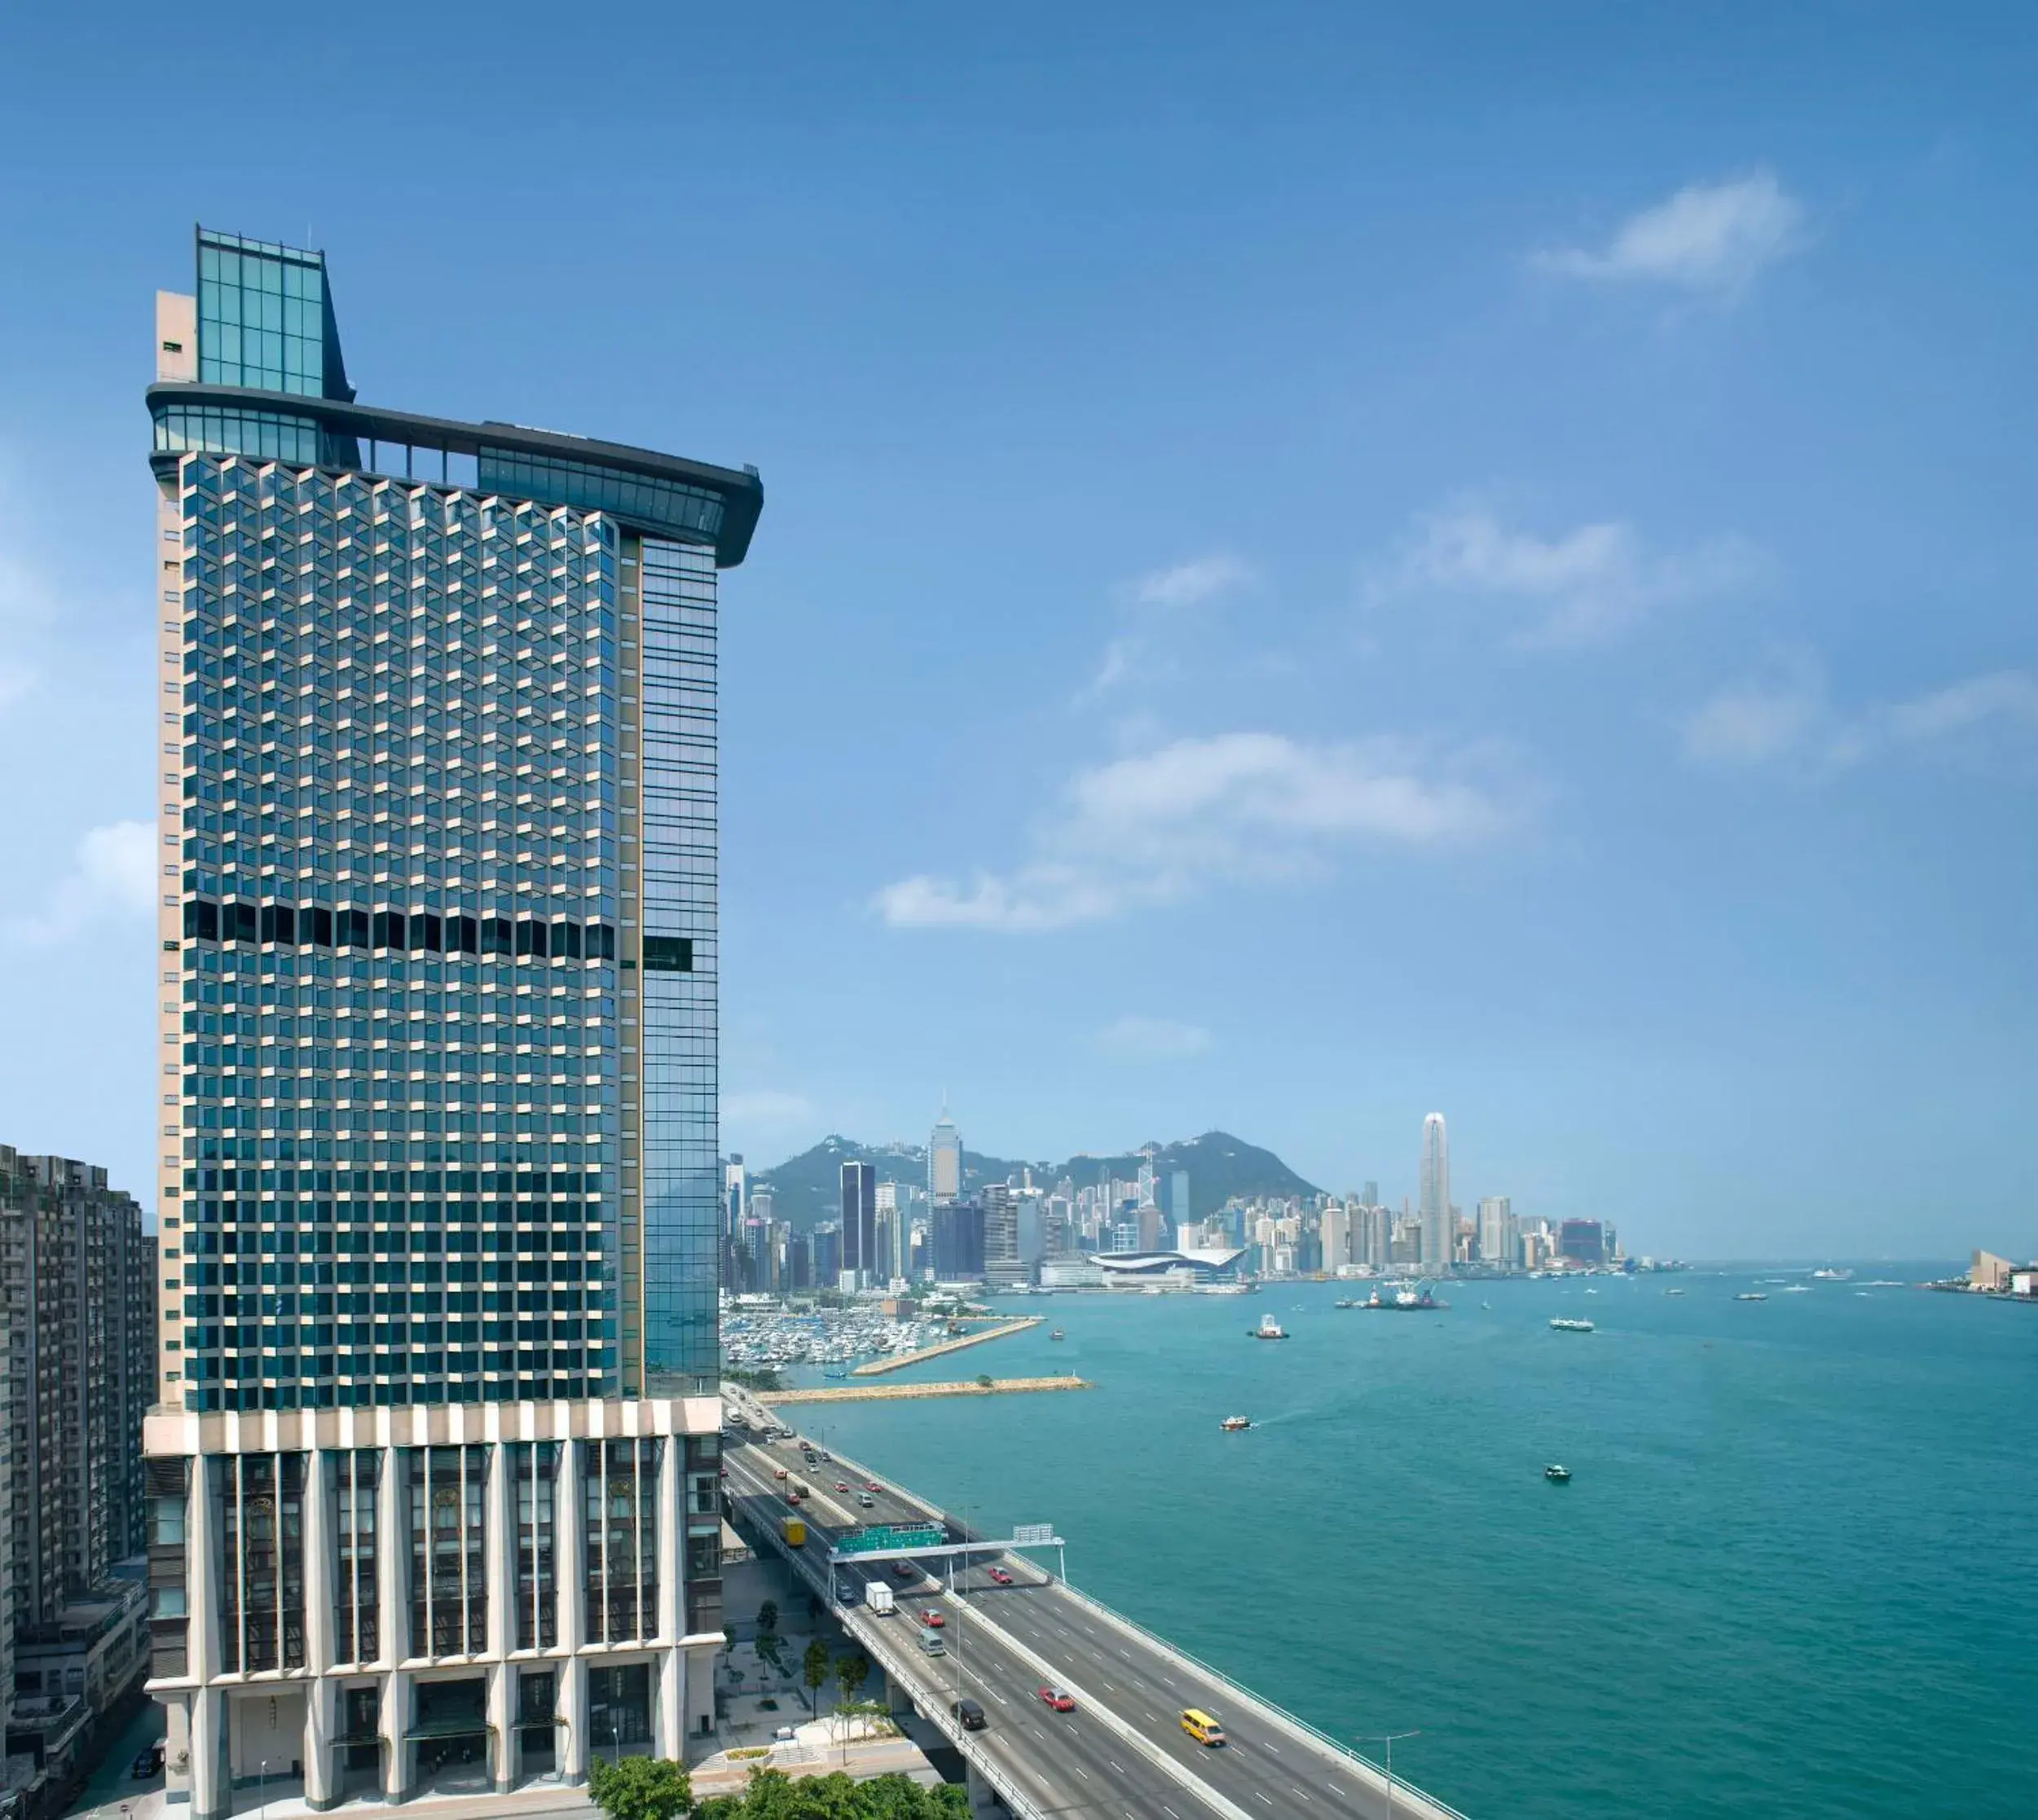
<box><xmin>1366</xmin><ymin>505</ymin><xmax>1765</xmax><ymax>648</ymax></box>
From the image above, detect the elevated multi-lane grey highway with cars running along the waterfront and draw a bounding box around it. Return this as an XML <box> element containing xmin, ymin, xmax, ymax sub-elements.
<box><xmin>725</xmin><ymin>1402</ymin><xmax>1451</xmax><ymax>1820</ymax></box>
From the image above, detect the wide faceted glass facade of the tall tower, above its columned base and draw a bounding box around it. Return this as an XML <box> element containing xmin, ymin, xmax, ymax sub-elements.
<box><xmin>165</xmin><ymin>455</ymin><xmax>623</xmax><ymax>1410</ymax></box>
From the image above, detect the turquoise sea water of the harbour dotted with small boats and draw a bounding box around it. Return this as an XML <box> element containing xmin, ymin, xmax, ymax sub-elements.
<box><xmin>778</xmin><ymin>1264</ymin><xmax>2038</xmax><ymax>1820</ymax></box>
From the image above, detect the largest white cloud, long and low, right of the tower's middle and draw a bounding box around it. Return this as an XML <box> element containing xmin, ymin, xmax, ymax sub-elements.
<box><xmin>874</xmin><ymin>734</ymin><xmax>1514</xmax><ymax>934</ymax></box>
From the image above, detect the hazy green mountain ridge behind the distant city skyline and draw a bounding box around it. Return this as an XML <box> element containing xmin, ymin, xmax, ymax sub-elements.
<box><xmin>750</xmin><ymin>1131</ymin><xmax>1323</xmax><ymax>1231</ymax></box>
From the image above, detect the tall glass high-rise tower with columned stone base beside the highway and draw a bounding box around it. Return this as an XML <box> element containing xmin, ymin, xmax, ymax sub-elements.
<box><xmin>145</xmin><ymin>231</ymin><xmax>762</xmax><ymax>1820</ymax></box>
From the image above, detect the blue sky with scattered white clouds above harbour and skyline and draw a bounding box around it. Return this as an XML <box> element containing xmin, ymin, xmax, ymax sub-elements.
<box><xmin>0</xmin><ymin>4</ymin><xmax>2038</xmax><ymax>1258</ymax></box>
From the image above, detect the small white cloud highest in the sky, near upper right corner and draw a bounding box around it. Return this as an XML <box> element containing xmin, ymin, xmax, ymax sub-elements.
<box><xmin>1534</xmin><ymin>171</ymin><xmax>1803</xmax><ymax>297</ymax></box>
